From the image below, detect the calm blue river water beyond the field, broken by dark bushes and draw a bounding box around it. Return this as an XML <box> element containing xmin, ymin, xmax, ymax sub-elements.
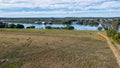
<box><xmin>8</xmin><ymin>22</ymin><xmax>104</xmax><ymax>30</ymax></box>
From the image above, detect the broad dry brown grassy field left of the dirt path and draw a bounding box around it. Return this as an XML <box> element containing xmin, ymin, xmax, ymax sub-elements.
<box><xmin>0</xmin><ymin>29</ymin><xmax>119</xmax><ymax>68</ymax></box>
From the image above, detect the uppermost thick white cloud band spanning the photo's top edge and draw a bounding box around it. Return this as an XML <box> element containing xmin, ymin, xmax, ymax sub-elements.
<box><xmin>0</xmin><ymin>0</ymin><xmax>120</xmax><ymax>10</ymax></box>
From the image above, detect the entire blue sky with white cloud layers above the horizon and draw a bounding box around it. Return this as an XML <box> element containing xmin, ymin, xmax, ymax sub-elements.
<box><xmin>0</xmin><ymin>0</ymin><xmax>120</xmax><ymax>17</ymax></box>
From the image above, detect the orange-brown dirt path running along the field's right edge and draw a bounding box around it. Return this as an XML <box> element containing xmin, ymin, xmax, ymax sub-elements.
<box><xmin>98</xmin><ymin>33</ymin><xmax>120</xmax><ymax>67</ymax></box>
